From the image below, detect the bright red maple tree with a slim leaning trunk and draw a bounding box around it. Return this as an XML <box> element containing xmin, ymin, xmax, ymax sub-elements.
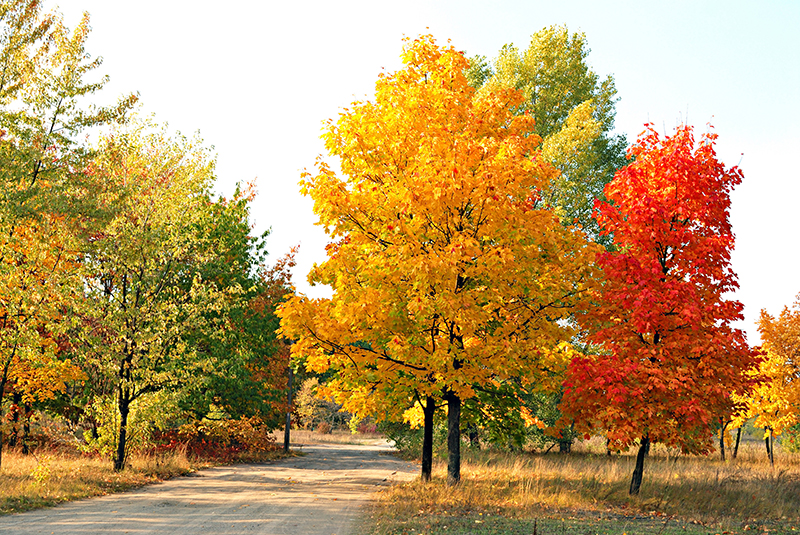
<box><xmin>561</xmin><ymin>125</ymin><xmax>758</xmax><ymax>494</ymax></box>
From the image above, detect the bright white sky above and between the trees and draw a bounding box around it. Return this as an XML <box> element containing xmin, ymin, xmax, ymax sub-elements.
<box><xmin>54</xmin><ymin>0</ymin><xmax>800</xmax><ymax>343</ymax></box>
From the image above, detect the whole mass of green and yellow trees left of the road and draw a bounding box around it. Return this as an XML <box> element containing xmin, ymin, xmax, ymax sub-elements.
<box><xmin>0</xmin><ymin>0</ymin><xmax>292</xmax><ymax>469</ymax></box>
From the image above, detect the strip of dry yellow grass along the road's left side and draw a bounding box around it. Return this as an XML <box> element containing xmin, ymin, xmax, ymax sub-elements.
<box><xmin>0</xmin><ymin>450</ymin><xmax>294</xmax><ymax>514</ymax></box>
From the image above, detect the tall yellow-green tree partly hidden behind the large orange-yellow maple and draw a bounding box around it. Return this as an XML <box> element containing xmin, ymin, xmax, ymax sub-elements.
<box><xmin>470</xmin><ymin>26</ymin><xmax>628</xmax><ymax>246</ymax></box>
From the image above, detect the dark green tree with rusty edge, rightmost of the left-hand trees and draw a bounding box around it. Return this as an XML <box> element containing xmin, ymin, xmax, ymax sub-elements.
<box><xmin>179</xmin><ymin>187</ymin><xmax>293</xmax><ymax>427</ymax></box>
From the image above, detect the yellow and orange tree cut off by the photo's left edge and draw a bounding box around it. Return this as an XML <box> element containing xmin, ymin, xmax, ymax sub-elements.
<box><xmin>0</xmin><ymin>0</ymin><xmax>135</xmax><ymax>466</ymax></box>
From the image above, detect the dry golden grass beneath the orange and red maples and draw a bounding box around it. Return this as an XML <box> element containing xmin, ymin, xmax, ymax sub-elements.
<box><xmin>370</xmin><ymin>443</ymin><xmax>800</xmax><ymax>534</ymax></box>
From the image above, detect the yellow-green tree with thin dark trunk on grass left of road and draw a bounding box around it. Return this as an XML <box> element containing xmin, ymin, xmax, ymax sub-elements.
<box><xmin>76</xmin><ymin>120</ymin><xmax>228</xmax><ymax>470</ymax></box>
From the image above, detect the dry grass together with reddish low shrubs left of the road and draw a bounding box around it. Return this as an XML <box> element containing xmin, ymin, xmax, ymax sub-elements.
<box><xmin>0</xmin><ymin>414</ymin><xmax>294</xmax><ymax>515</ymax></box>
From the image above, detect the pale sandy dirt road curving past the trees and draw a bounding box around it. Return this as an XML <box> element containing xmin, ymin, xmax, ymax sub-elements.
<box><xmin>0</xmin><ymin>444</ymin><xmax>418</xmax><ymax>535</ymax></box>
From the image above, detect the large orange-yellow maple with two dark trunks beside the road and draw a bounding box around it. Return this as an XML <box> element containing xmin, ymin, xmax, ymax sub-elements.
<box><xmin>279</xmin><ymin>36</ymin><xmax>595</xmax><ymax>484</ymax></box>
